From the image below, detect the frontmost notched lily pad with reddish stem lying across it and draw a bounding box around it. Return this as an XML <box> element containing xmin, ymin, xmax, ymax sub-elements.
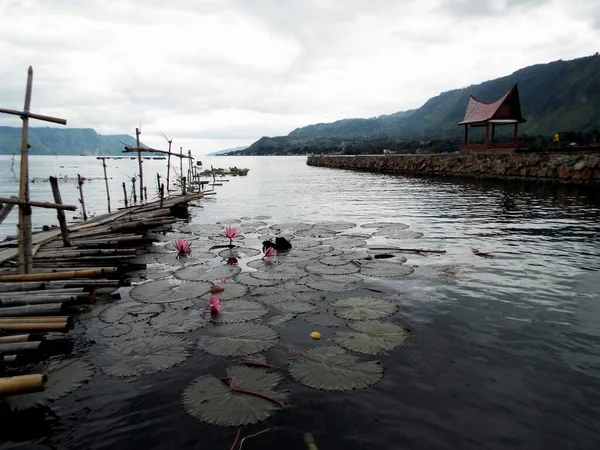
<box><xmin>182</xmin><ymin>366</ymin><xmax>287</xmax><ymax>426</ymax></box>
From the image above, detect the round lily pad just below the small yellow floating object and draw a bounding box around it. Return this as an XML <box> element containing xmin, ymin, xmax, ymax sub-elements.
<box><xmin>289</xmin><ymin>346</ymin><xmax>383</xmax><ymax>391</ymax></box>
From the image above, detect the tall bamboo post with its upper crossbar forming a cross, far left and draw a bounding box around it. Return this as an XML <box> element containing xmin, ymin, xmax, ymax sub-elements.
<box><xmin>0</xmin><ymin>66</ymin><xmax>70</xmax><ymax>273</ymax></box>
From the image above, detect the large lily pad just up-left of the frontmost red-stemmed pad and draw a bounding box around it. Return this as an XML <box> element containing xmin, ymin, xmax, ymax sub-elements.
<box><xmin>99</xmin><ymin>335</ymin><xmax>191</xmax><ymax>377</ymax></box>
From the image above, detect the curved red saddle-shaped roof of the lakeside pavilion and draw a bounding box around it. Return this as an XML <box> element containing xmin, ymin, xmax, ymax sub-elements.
<box><xmin>458</xmin><ymin>84</ymin><xmax>525</xmax><ymax>125</ymax></box>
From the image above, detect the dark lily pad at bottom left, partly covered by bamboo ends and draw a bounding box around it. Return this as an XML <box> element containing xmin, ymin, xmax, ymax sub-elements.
<box><xmin>4</xmin><ymin>359</ymin><xmax>94</xmax><ymax>410</ymax></box>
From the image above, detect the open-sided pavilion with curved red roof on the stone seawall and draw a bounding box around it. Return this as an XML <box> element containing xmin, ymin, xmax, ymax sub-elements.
<box><xmin>458</xmin><ymin>84</ymin><xmax>526</xmax><ymax>152</ymax></box>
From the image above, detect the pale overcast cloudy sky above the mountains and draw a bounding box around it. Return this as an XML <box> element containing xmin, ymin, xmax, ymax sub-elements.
<box><xmin>0</xmin><ymin>0</ymin><xmax>600</xmax><ymax>154</ymax></box>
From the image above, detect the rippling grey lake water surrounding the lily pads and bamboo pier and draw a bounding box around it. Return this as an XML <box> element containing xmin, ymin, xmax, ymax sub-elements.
<box><xmin>0</xmin><ymin>157</ymin><xmax>600</xmax><ymax>450</ymax></box>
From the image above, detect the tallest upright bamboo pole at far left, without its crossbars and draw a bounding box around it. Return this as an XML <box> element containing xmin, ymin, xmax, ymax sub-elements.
<box><xmin>19</xmin><ymin>66</ymin><xmax>33</xmax><ymax>274</ymax></box>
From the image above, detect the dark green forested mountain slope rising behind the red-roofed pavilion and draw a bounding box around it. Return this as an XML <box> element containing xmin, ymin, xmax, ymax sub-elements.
<box><xmin>241</xmin><ymin>53</ymin><xmax>600</xmax><ymax>155</ymax></box>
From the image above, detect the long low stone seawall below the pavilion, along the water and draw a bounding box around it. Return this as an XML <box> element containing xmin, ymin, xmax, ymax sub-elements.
<box><xmin>307</xmin><ymin>151</ymin><xmax>600</xmax><ymax>184</ymax></box>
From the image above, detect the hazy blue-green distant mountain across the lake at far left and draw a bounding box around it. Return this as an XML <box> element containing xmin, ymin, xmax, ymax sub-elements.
<box><xmin>0</xmin><ymin>126</ymin><xmax>143</xmax><ymax>155</ymax></box>
